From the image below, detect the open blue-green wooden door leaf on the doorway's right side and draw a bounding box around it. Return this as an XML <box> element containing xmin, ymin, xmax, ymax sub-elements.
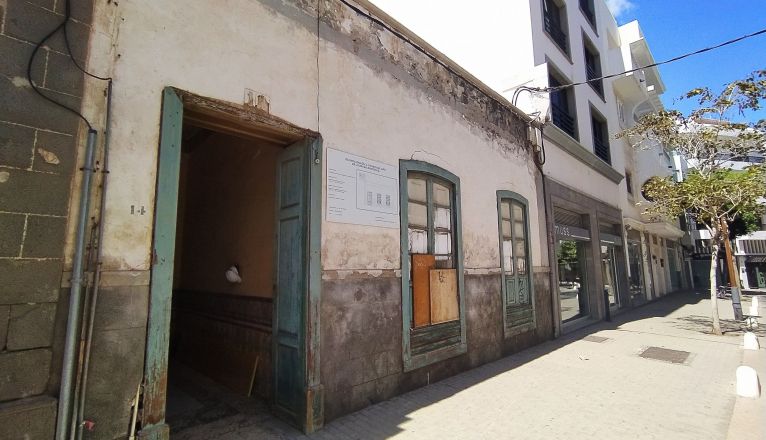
<box><xmin>272</xmin><ymin>138</ymin><xmax>323</xmax><ymax>432</ymax></box>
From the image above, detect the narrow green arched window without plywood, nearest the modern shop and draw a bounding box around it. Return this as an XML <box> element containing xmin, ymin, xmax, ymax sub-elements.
<box><xmin>497</xmin><ymin>191</ymin><xmax>535</xmax><ymax>337</ymax></box>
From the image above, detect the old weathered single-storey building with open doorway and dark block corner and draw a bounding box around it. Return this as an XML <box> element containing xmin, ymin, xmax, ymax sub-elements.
<box><xmin>0</xmin><ymin>0</ymin><xmax>555</xmax><ymax>439</ymax></box>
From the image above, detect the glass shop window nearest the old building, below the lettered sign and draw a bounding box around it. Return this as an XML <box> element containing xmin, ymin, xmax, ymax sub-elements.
<box><xmin>556</xmin><ymin>240</ymin><xmax>588</xmax><ymax>322</ymax></box>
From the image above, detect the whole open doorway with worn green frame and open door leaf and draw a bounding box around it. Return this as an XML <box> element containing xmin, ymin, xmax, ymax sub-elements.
<box><xmin>141</xmin><ymin>88</ymin><xmax>323</xmax><ymax>438</ymax></box>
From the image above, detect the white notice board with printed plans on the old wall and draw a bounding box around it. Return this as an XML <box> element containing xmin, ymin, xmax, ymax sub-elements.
<box><xmin>327</xmin><ymin>148</ymin><xmax>399</xmax><ymax>228</ymax></box>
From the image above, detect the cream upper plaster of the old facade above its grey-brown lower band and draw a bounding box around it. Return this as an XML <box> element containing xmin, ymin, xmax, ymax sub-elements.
<box><xmin>90</xmin><ymin>0</ymin><xmax>541</xmax><ymax>276</ymax></box>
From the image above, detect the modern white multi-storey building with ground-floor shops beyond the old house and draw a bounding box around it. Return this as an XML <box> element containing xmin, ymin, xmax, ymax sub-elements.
<box><xmin>375</xmin><ymin>0</ymin><xmax>684</xmax><ymax>333</ymax></box>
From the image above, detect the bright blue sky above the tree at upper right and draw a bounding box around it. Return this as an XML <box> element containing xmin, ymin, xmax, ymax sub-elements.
<box><xmin>607</xmin><ymin>0</ymin><xmax>766</xmax><ymax>122</ymax></box>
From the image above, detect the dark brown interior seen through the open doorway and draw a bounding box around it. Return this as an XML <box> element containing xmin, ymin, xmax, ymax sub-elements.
<box><xmin>166</xmin><ymin>123</ymin><xmax>283</xmax><ymax>432</ymax></box>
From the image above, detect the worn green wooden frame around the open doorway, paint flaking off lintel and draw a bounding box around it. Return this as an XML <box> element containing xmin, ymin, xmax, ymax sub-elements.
<box><xmin>138</xmin><ymin>87</ymin><xmax>324</xmax><ymax>439</ymax></box>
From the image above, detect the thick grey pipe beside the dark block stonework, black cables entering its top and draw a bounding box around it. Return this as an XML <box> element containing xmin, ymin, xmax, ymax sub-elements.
<box><xmin>56</xmin><ymin>128</ymin><xmax>97</xmax><ymax>440</ymax></box>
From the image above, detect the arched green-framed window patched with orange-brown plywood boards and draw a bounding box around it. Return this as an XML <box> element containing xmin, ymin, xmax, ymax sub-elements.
<box><xmin>399</xmin><ymin>160</ymin><xmax>466</xmax><ymax>371</ymax></box>
